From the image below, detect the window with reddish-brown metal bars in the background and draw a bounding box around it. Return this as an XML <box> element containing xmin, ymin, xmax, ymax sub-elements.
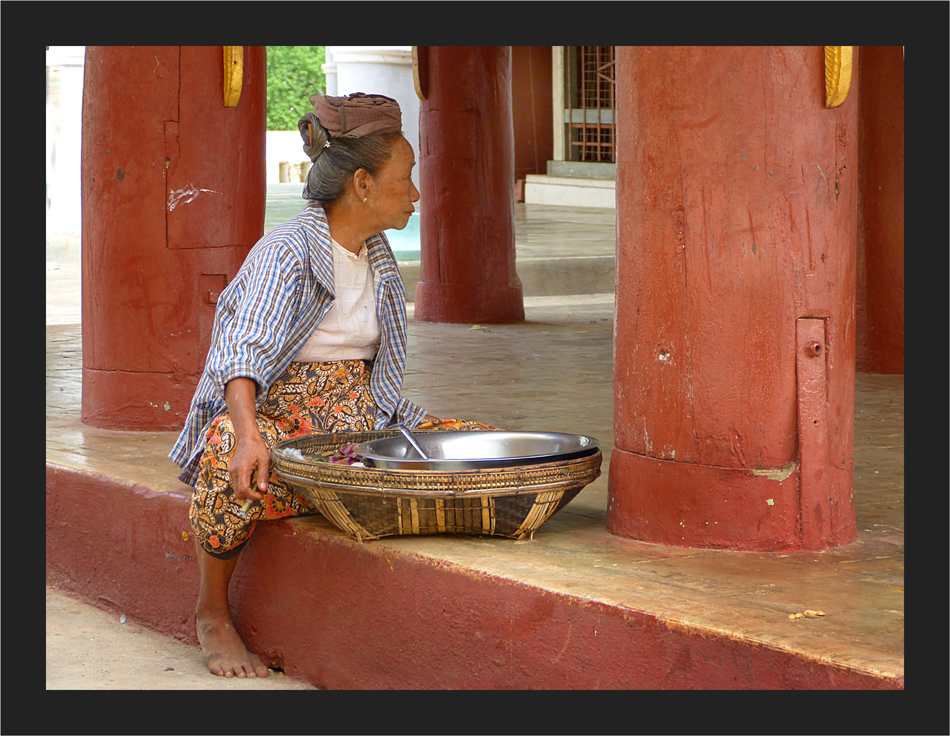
<box><xmin>564</xmin><ymin>46</ymin><xmax>616</xmax><ymax>163</ymax></box>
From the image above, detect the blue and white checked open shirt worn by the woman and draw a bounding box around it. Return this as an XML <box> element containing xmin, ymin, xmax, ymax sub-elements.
<box><xmin>168</xmin><ymin>205</ymin><xmax>425</xmax><ymax>485</ymax></box>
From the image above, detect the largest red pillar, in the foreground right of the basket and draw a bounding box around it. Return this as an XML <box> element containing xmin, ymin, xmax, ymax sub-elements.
<box><xmin>608</xmin><ymin>46</ymin><xmax>857</xmax><ymax>550</ymax></box>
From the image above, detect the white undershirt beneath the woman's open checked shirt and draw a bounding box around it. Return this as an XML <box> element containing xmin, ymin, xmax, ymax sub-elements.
<box><xmin>294</xmin><ymin>238</ymin><xmax>379</xmax><ymax>363</ymax></box>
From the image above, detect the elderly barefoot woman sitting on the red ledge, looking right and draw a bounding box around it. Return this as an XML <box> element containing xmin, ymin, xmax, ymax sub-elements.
<box><xmin>170</xmin><ymin>94</ymin><xmax>484</xmax><ymax>677</ymax></box>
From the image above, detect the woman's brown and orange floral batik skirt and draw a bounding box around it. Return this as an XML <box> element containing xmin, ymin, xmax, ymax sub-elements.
<box><xmin>189</xmin><ymin>360</ymin><xmax>376</xmax><ymax>559</ymax></box>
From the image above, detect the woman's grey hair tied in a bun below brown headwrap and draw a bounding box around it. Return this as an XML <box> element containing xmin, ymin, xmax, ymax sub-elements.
<box><xmin>303</xmin><ymin>123</ymin><xmax>403</xmax><ymax>206</ymax></box>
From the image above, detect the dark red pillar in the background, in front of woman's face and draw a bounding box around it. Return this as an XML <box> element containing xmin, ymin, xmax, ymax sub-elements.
<box><xmin>415</xmin><ymin>46</ymin><xmax>524</xmax><ymax>324</ymax></box>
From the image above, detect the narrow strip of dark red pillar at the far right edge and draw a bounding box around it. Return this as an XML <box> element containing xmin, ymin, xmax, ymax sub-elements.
<box><xmin>856</xmin><ymin>46</ymin><xmax>904</xmax><ymax>373</ymax></box>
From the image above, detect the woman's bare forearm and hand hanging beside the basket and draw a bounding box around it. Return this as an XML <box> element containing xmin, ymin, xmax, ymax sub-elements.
<box><xmin>224</xmin><ymin>378</ymin><xmax>270</xmax><ymax>501</ymax></box>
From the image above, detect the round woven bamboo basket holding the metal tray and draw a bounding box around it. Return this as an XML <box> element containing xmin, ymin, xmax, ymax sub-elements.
<box><xmin>271</xmin><ymin>430</ymin><xmax>603</xmax><ymax>542</ymax></box>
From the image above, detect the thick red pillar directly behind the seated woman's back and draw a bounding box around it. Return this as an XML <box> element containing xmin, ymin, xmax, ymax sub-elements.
<box><xmin>82</xmin><ymin>46</ymin><xmax>266</xmax><ymax>430</ymax></box>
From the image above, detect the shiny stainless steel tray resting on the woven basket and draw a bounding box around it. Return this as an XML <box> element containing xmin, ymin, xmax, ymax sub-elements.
<box><xmin>356</xmin><ymin>431</ymin><xmax>600</xmax><ymax>470</ymax></box>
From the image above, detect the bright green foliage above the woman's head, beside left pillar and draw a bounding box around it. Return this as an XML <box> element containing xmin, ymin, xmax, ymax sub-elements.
<box><xmin>267</xmin><ymin>46</ymin><xmax>327</xmax><ymax>130</ymax></box>
